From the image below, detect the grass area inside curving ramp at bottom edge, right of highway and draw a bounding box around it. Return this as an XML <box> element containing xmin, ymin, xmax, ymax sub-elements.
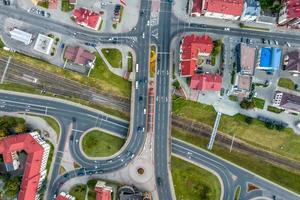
<box><xmin>171</xmin><ymin>156</ymin><xmax>221</xmax><ymax>200</ymax></box>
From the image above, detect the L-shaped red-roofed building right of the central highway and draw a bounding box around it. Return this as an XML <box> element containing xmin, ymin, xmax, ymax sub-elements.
<box><xmin>179</xmin><ymin>34</ymin><xmax>214</xmax><ymax>77</ymax></box>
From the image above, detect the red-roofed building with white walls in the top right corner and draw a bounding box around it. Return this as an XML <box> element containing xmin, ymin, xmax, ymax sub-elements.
<box><xmin>278</xmin><ymin>0</ymin><xmax>300</xmax><ymax>26</ymax></box>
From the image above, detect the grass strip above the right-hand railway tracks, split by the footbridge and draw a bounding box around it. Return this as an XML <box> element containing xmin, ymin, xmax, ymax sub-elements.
<box><xmin>173</xmin><ymin>98</ymin><xmax>300</xmax><ymax>161</ymax></box>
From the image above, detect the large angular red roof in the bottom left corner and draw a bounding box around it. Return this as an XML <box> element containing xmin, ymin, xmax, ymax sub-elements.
<box><xmin>0</xmin><ymin>133</ymin><xmax>44</xmax><ymax>200</ymax></box>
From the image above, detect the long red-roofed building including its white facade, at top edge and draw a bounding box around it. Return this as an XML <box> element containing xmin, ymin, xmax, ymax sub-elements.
<box><xmin>191</xmin><ymin>0</ymin><xmax>244</xmax><ymax>20</ymax></box>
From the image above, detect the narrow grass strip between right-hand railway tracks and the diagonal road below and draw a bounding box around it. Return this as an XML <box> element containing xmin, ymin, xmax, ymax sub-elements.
<box><xmin>172</xmin><ymin>129</ymin><xmax>300</xmax><ymax>193</ymax></box>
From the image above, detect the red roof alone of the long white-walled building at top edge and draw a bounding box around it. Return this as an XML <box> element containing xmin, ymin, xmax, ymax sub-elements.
<box><xmin>204</xmin><ymin>0</ymin><xmax>244</xmax><ymax>16</ymax></box>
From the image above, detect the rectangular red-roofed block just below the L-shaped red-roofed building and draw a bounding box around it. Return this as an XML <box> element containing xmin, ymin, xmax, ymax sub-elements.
<box><xmin>190</xmin><ymin>74</ymin><xmax>222</xmax><ymax>91</ymax></box>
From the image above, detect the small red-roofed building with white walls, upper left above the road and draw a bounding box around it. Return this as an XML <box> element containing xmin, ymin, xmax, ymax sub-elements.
<box><xmin>73</xmin><ymin>8</ymin><xmax>101</xmax><ymax>30</ymax></box>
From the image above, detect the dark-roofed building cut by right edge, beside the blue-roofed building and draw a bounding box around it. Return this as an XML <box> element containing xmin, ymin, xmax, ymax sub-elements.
<box><xmin>283</xmin><ymin>49</ymin><xmax>300</xmax><ymax>75</ymax></box>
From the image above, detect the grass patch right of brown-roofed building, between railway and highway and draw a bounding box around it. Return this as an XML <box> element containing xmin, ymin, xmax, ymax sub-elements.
<box><xmin>90</xmin><ymin>54</ymin><xmax>131</xmax><ymax>97</ymax></box>
